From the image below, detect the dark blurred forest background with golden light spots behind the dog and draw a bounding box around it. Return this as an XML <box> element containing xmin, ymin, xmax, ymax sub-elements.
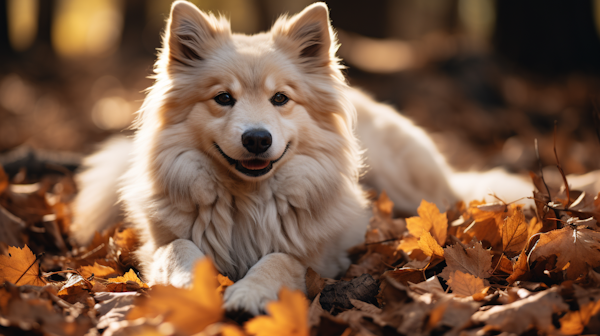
<box><xmin>0</xmin><ymin>0</ymin><xmax>600</xmax><ymax>177</ymax></box>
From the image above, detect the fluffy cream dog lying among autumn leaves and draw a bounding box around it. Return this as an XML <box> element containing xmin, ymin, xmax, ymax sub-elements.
<box><xmin>72</xmin><ymin>1</ymin><xmax>530</xmax><ymax>314</ymax></box>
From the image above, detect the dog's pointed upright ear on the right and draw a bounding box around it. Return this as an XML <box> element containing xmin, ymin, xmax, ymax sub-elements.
<box><xmin>273</xmin><ymin>2</ymin><xmax>336</xmax><ymax>66</ymax></box>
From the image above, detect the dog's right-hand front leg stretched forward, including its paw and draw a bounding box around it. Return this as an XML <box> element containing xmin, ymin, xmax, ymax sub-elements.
<box><xmin>225</xmin><ymin>253</ymin><xmax>306</xmax><ymax>315</ymax></box>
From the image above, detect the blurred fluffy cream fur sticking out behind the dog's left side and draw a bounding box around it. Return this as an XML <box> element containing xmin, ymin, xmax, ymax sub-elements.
<box><xmin>70</xmin><ymin>136</ymin><xmax>133</xmax><ymax>245</ymax></box>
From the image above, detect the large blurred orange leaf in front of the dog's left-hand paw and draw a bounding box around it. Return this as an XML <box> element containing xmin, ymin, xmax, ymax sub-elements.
<box><xmin>127</xmin><ymin>258</ymin><xmax>224</xmax><ymax>334</ymax></box>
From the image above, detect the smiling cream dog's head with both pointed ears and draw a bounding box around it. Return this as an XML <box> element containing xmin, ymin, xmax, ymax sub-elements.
<box><xmin>151</xmin><ymin>1</ymin><xmax>354</xmax><ymax>181</ymax></box>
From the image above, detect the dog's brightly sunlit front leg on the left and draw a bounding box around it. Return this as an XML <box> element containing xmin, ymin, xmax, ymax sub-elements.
<box><xmin>149</xmin><ymin>239</ymin><xmax>204</xmax><ymax>287</ymax></box>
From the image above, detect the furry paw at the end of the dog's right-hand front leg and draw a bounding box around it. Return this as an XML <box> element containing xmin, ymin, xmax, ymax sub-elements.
<box><xmin>224</xmin><ymin>279</ymin><xmax>279</xmax><ymax>315</ymax></box>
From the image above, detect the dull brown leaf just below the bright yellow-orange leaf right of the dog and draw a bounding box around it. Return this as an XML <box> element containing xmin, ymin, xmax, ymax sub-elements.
<box><xmin>440</xmin><ymin>243</ymin><xmax>492</xmax><ymax>280</ymax></box>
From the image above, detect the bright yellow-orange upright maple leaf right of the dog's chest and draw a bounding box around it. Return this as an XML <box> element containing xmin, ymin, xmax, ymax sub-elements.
<box><xmin>406</xmin><ymin>200</ymin><xmax>448</xmax><ymax>246</ymax></box>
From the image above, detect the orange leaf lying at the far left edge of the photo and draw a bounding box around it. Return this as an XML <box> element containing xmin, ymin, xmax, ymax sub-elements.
<box><xmin>0</xmin><ymin>245</ymin><xmax>46</xmax><ymax>286</ymax></box>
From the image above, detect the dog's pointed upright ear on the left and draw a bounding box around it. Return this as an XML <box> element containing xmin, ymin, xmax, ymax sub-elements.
<box><xmin>163</xmin><ymin>1</ymin><xmax>231</xmax><ymax>68</ymax></box>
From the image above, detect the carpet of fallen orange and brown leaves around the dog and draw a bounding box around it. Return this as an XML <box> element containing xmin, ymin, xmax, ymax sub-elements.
<box><xmin>0</xmin><ymin>161</ymin><xmax>600</xmax><ymax>336</ymax></box>
